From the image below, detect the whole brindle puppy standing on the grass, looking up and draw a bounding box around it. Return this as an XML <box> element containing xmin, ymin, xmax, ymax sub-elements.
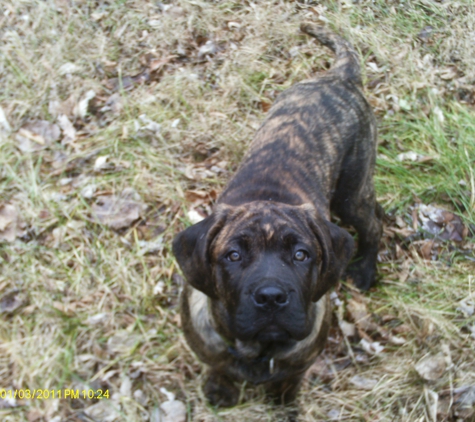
<box><xmin>173</xmin><ymin>24</ymin><xmax>382</xmax><ymax>406</ymax></box>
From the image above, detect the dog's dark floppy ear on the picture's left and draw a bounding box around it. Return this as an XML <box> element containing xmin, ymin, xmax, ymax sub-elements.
<box><xmin>173</xmin><ymin>207</ymin><xmax>231</xmax><ymax>299</ymax></box>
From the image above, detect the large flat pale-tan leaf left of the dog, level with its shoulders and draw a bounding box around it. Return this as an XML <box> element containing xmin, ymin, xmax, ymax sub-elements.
<box><xmin>92</xmin><ymin>189</ymin><xmax>147</xmax><ymax>230</ymax></box>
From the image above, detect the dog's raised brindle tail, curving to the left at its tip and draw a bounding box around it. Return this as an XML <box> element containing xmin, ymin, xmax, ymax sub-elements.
<box><xmin>300</xmin><ymin>22</ymin><xmax>362</xmax><ymax>85</ymax></box>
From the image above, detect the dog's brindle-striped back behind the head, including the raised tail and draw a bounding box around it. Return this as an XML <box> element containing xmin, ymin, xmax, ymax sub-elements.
<box><xmin>220</xmin><ymin>24</ymin><xmax>376</xmax><ymax>217</ymax></box>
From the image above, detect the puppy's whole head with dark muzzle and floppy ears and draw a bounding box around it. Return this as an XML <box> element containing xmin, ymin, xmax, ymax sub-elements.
<box><xmin>173</xmin><ymin>201</ymin><xmax>353</xmax><ymax>343</ymax></box>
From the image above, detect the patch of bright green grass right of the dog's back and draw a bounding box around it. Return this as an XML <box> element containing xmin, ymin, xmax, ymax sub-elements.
<box><xmin>377</xmin><ymin>103</ymin><xmax>475</xmax><ymax>216</ymax></box>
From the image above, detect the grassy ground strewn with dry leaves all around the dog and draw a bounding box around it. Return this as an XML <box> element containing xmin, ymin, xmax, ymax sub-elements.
<box><xmin>0</xmin><ymin>0</ymin><xmax>475</xmax><ymax>422</ymax></box>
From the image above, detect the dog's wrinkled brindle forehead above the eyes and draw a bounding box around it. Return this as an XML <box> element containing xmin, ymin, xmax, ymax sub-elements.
<box><xmin>215</xmin><ymin>203</ymin><xmax>313</xmax><ymax>251</ymax></box>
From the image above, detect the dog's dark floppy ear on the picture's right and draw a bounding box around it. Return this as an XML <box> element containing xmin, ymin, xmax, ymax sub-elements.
<box><xmin>305</xmin><ymin>206</ymin><xmax>355</xmax><ymax>302</ymax></box>
